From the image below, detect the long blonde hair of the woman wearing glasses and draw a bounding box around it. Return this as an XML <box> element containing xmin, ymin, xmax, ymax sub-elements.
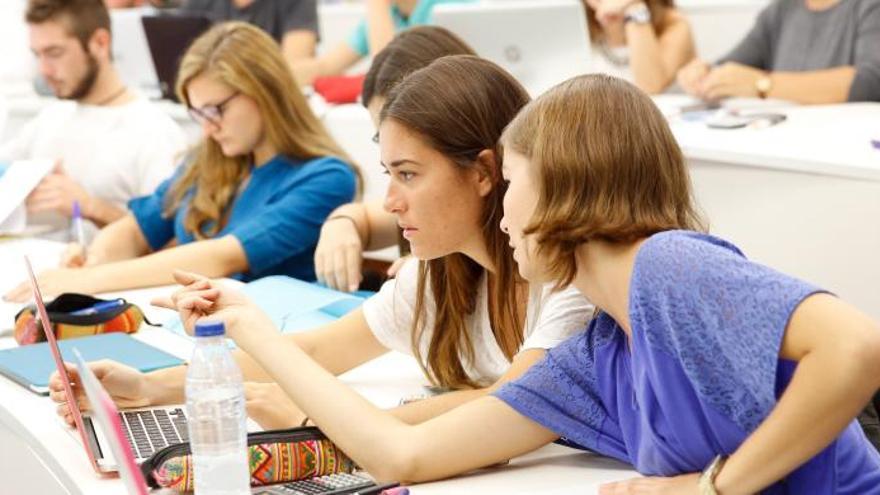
<box><xmin>163</xmin><ymin>22</ymin><xmax>361</xmax><ymax>239</ymax></box>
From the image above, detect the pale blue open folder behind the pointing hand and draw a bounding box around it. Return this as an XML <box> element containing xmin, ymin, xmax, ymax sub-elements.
<box><xmin>163</xmin><ymin>275</ymin><xmax>372</xmax><ymax>335</ymax></box>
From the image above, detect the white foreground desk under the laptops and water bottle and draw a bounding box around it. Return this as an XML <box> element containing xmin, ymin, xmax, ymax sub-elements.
<box><xmin>0</xmin><ymin>241</ymin><xmax>636</xmax><ymax>495</ymax></box>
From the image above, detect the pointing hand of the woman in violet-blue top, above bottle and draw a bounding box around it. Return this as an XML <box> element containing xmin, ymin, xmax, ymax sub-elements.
<box><xmin>150</xmin><ymin>270</ymin><xmax>274</xmax><ymax>340</ymax></box>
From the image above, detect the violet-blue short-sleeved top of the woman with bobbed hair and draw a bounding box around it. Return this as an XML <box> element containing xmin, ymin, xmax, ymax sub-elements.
<box><xmin>495</xmin><ymin>231</ymin><xmax>880</xmax><ymax>495</ymax></box>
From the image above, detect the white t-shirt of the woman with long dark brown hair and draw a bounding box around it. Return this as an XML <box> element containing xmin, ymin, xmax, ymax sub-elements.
<box><xmin>363</xmin><ymin>259</ymin><xmax>593</xmax><ymax>386</ymax></box>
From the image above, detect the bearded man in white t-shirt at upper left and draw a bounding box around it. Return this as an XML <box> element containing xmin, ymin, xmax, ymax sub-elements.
<box><xmin>0</xmin><ymin>0</ymin><xmax>186</xmax><ymax>232</ymax></box>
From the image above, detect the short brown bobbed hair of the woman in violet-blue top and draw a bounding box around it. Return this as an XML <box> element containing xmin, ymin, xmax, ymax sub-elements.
<box><xmin>502</xmin><ymin>74</ymin><xmax>706</xmax><ymax>287</ymax></box>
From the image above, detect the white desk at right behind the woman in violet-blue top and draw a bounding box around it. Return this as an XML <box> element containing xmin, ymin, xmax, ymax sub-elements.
<box><xmin>660</xmin><ymin>98</ymin><xmax>880</xmax><ymax>318</ymax></box>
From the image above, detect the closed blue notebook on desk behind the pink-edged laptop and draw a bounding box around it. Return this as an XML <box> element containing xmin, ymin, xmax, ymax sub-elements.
<box><xmin>0</xmin><ymin>333</ymin><xmax>183</xmax><ymax>395</ymax></box>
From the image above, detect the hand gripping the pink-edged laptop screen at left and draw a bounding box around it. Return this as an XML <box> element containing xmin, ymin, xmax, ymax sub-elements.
<box><xmin>49</xmin><ymin>359</ymin><xmax>156</xmax><ymax>426</ymax></box>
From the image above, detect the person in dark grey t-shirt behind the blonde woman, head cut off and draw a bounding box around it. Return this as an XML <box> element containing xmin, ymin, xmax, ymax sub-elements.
<box><xmin>179</xmin><ymin>0</ymin><xmax>318</xmax><ymax>63</ymax></box>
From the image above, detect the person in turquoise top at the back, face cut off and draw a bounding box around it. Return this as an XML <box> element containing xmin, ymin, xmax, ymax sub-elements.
<box><xmin>293</xmin><ymin>0</ymin><xmax>473</xmax><ymax>86</ymax></box>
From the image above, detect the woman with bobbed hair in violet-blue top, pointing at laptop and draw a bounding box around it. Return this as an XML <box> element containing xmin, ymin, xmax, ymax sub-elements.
<box><xmin>144</xmin><ymin>73</ymin><xmax>880</xmax><ymax>495</ymax></box>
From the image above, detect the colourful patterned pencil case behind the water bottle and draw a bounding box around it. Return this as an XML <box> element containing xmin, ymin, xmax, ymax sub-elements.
<box><xmin>141</xmin><ymin>426</ymin><xmax>355</xmax><ymax>492</ymax></box>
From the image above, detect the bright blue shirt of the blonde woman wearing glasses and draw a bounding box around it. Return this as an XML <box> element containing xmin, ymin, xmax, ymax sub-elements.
<box><xmin>128</xmin><ymin>155</ymin><xmax>356</xmax><ymax>281</ymax></box>
